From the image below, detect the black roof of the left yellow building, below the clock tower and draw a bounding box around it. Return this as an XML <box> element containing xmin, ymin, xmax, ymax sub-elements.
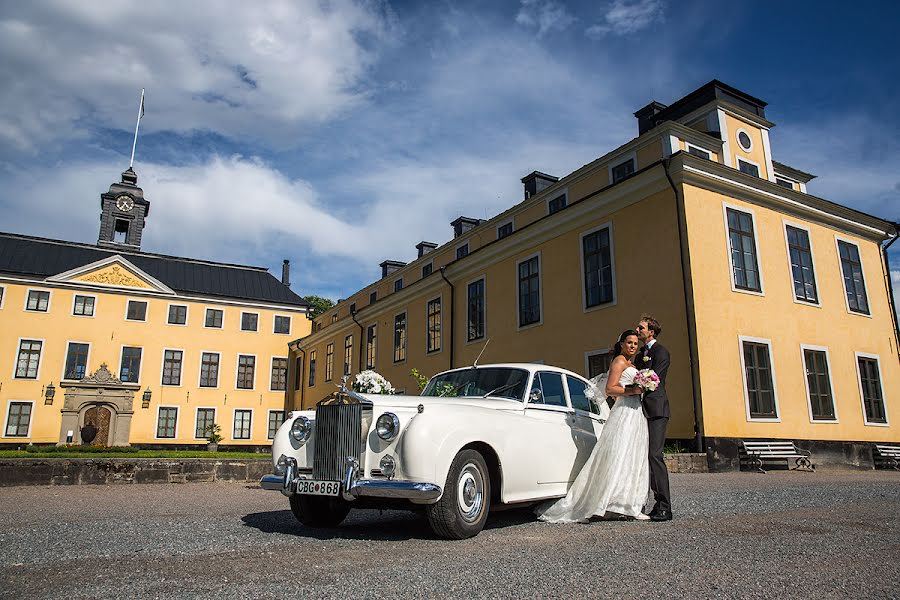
<box><xmin>0</xmin><ymin>232</ymin><xmax>308</xmax><ymax>307</ymax></box>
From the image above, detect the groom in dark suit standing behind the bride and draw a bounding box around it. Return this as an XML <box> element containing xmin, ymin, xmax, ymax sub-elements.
<box><xmin>634</xmin><ymin>315</ymin><xmax>672</xmax><ymax>521</ymax></box>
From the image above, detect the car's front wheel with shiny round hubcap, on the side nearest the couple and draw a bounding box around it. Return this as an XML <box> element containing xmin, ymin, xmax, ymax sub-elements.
<box><xmin>427</xmin><ymin>450</ymin><xmax>491</xmax><ymax>540</ymax></box>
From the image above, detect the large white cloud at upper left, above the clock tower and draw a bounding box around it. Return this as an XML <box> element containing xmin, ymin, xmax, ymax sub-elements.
<box><xmin>0</xmin><ymin>0</ymin><xmax>395</xmax><ymax>151</ymax></box>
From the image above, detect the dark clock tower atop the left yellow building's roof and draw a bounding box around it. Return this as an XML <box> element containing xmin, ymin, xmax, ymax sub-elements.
<box><xmin>97</xmin><ymin>167</ymin><xmax>150</xmax><ymax>250</ymax></box>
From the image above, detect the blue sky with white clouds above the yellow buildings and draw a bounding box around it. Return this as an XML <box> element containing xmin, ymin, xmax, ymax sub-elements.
<box><xmin>0</xmin><ymin>0</ymin><xmax>900</xmax><ymax>299</ymax></box>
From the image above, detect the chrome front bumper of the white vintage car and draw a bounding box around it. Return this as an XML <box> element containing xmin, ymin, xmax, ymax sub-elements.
<box><xmin>259</xmin><ymin>458</ymin><xmax>443</xmax><ymax>502</ymax></box>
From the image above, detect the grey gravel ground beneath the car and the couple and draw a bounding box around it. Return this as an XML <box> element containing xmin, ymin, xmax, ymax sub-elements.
<box><xmin>0</xmin><ymin>471</ymin><xmax>900</xmax><ymax>599</ymax></box>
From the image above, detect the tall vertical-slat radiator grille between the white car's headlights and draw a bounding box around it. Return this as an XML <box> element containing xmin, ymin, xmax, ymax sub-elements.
<box><xmin>313</xmin><ymin>404</ymin><xmax>372</xmax><ymax>481</ymax></box>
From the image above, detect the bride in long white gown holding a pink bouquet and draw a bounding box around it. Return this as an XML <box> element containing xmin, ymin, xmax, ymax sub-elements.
<box><xmin>536</xmin><ymin>329</ymin><xmax>650</xmax><ymax>523</ymax></box>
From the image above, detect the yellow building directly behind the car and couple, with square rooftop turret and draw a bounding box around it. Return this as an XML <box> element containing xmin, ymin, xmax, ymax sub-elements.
<box><xmin>288</xmin><ymin>81</ymin><xmax>900</xmax><ymax>468</ymax></box>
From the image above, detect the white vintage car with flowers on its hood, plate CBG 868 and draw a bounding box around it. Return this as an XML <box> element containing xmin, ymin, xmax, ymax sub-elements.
<box><xmin>260</xmin><ymin>364</ymin><xmax>609</xmax><ymax>539</ymax></box>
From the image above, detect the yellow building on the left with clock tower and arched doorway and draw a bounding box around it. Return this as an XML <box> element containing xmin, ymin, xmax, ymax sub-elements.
<box><xmin>0</xmin><ymin>168</ymin><xmax>310</xmax><ymax>447</ymax></box>
